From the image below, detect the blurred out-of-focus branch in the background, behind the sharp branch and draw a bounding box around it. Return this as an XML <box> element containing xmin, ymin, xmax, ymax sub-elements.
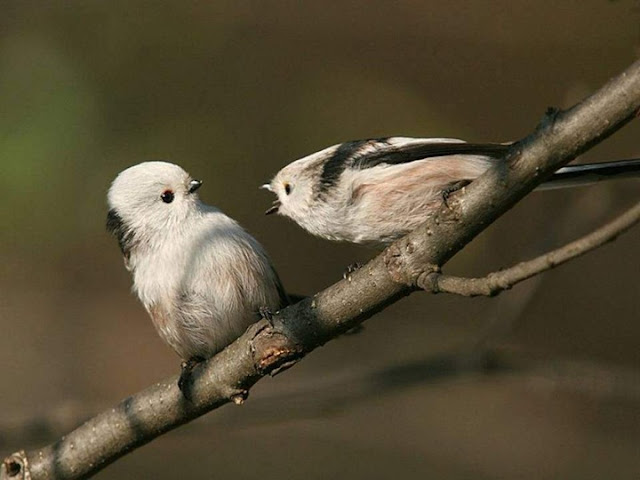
<box><xmin>5</xmin><ymin>346</ymin><xmax>640</xmax><ymax>446</ymax></box>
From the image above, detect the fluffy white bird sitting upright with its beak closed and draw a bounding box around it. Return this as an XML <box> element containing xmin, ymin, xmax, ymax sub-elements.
<box><xmin>107</xmin><ymin>162</ymin><xmax>288</xmax><ymax>398</ymax></box>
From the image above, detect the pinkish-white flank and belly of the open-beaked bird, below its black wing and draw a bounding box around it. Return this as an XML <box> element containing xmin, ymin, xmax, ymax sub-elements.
<box><xmin>316</xmin><ymin>155</ymin><xmax>491</xmax><ymax>244</ymax></box>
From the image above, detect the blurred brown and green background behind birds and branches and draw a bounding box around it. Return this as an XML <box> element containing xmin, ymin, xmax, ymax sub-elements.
<box><xmin>0</xmin><ymin>0</ymin><xmax>640</xmax><ymax>480</ymax></box>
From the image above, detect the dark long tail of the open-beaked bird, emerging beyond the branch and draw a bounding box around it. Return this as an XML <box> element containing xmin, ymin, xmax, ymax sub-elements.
<box><xmin>538</xmin><ymin>158</ymin><xmax>640</xmax><ymax>190</ymax></box>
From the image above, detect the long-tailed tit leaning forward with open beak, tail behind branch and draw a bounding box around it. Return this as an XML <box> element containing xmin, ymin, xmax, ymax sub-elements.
<box><xmin>263</xmin><ymin>137</ymin><xmax>640</xmax><ymax>244</ymax></box>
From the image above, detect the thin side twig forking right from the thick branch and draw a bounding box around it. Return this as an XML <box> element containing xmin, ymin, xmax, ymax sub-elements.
<box><xmin>418</xmin><ymin>203</ymin><xmax>640</xmax><ymax>297</ymax></box>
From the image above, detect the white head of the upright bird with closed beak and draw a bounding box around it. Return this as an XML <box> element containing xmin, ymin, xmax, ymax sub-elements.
<box><xmin>107</xmin><ymin>162</ymin><xmax>202</xmax><ymax>257</ymax></box>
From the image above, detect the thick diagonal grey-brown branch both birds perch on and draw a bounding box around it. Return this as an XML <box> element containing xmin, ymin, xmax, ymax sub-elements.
<box><xmin>0</xmin><ymin>58</ymin><xmax>640</xmax><ymax>480</ymax></box>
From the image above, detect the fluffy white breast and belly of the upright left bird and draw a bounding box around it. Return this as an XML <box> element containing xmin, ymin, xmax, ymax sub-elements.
<box><xmin>131</xmin><ymin>211</ymin><xmax>280</xmax><ymax>359</ymax></box>
